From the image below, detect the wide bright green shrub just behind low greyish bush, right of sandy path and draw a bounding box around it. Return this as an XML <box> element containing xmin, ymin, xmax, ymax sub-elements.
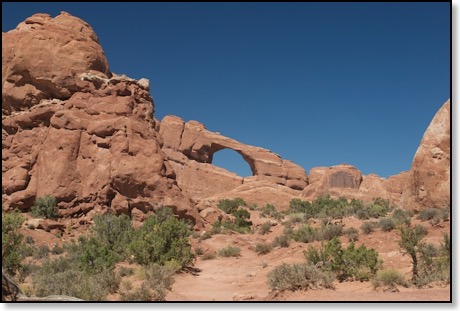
<box><xmin>304</xmin><ymin>237</ymin><xmax>381</xmax><ymax>281</ymax></box>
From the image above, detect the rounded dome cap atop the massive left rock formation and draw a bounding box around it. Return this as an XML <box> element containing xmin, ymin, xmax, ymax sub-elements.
<box><xmin>2</xmin><ymin>12</ymin><xmax>111</xmax><ymax>115</ymax></box>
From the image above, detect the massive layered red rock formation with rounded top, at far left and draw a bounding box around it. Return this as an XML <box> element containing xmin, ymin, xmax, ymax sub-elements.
<box><xmin>2</xmin><ymin>13</ymin><xmax>201</xmax><ymax>225</ymax></box>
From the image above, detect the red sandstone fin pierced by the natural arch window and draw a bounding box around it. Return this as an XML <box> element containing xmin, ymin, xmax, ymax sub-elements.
<box><xmin>160</xmin><ymin>116</ymin><xmax>308</xmax><ymax>199</ymax></box>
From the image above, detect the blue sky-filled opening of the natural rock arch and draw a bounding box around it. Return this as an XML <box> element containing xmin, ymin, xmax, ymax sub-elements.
<box><xmin>211</xmin><ymin>148</ymin><xmax>254</xmax><ymax>177</ymax></box>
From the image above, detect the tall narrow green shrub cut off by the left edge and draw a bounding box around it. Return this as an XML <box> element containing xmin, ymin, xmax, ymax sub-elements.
<box><xmin>2</xmin><ymin>211</ymin><xmax>25</xmax><ymax>276</ymax></box>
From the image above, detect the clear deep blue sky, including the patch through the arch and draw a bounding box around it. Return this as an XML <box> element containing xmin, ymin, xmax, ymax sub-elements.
<box><xmin>2</xmin><ymin>2</ymin><xmax>450</xmax><ymax>177</ymax></box>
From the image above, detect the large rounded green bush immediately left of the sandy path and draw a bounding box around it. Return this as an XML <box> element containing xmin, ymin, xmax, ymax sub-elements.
<box><xmin>129</xmin><ymin>208</ymin><xmax>194</xmax><ymax>267</ymax></box>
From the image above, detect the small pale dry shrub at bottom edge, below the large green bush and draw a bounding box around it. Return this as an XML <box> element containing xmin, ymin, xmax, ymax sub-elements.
<box><xmin>144</xmin><ymin>263</ymin><xmax>176</xmax><ymax>301</ymax></box>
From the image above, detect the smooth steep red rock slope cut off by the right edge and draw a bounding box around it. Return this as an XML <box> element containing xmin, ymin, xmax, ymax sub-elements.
<box><xmin>401</xmin><ymin>100</ymin><xmax>451</xmax><ymax>211</ymax></box>
